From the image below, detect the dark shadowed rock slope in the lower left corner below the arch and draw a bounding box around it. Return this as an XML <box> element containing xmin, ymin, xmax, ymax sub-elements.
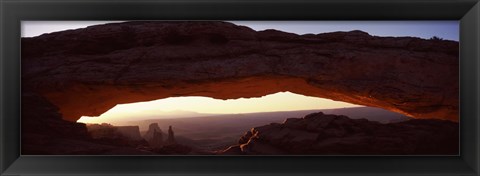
<box><xmin>21</xmin><ymin>91</ymin><xmax>153</xmax><ymax>155</ymax></box>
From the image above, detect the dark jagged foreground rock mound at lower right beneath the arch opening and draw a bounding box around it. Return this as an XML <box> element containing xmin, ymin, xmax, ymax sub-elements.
<box><xmin>221</xmin><ymin>112</ymin><xmax>459</xmax><ymax>155</ymax></box>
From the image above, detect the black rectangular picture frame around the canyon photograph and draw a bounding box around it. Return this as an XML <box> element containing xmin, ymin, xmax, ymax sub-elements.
<box><xmin>0</xmin><ymin>0</ymin><xmax>480</xmax><ymax>176</ymax></box>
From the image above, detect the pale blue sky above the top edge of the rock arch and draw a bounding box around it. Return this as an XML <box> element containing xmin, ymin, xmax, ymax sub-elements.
<box><xmin>21</xmin><ymin>21</ymin><xmax>459</xmax><ymax>41</ymax></box>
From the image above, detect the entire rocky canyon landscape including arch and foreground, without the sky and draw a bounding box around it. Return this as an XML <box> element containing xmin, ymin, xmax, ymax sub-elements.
<box><xmin>21</xmin><ymin>21</ymin><xmax>459</xmax><ymax>155</ymax></box>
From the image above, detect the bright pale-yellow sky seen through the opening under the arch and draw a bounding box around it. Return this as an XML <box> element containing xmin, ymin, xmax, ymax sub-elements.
<box><xmin>78</xmin><ymin>92</ymin><xmax>359</xmax><ymax>124</ymax></box>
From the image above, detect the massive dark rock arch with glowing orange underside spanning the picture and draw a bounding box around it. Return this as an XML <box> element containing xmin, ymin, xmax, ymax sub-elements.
<box><xmin>21</xmin><ymin>21</ymin><xmax>459</xmax><ymax>121</ymax></box>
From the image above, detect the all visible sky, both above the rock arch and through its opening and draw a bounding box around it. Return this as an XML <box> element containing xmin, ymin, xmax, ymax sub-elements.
<box><xmin>21</xmin><ymin>21</ymin><xmax>459</xmax><ymax>125</ymax></box>
